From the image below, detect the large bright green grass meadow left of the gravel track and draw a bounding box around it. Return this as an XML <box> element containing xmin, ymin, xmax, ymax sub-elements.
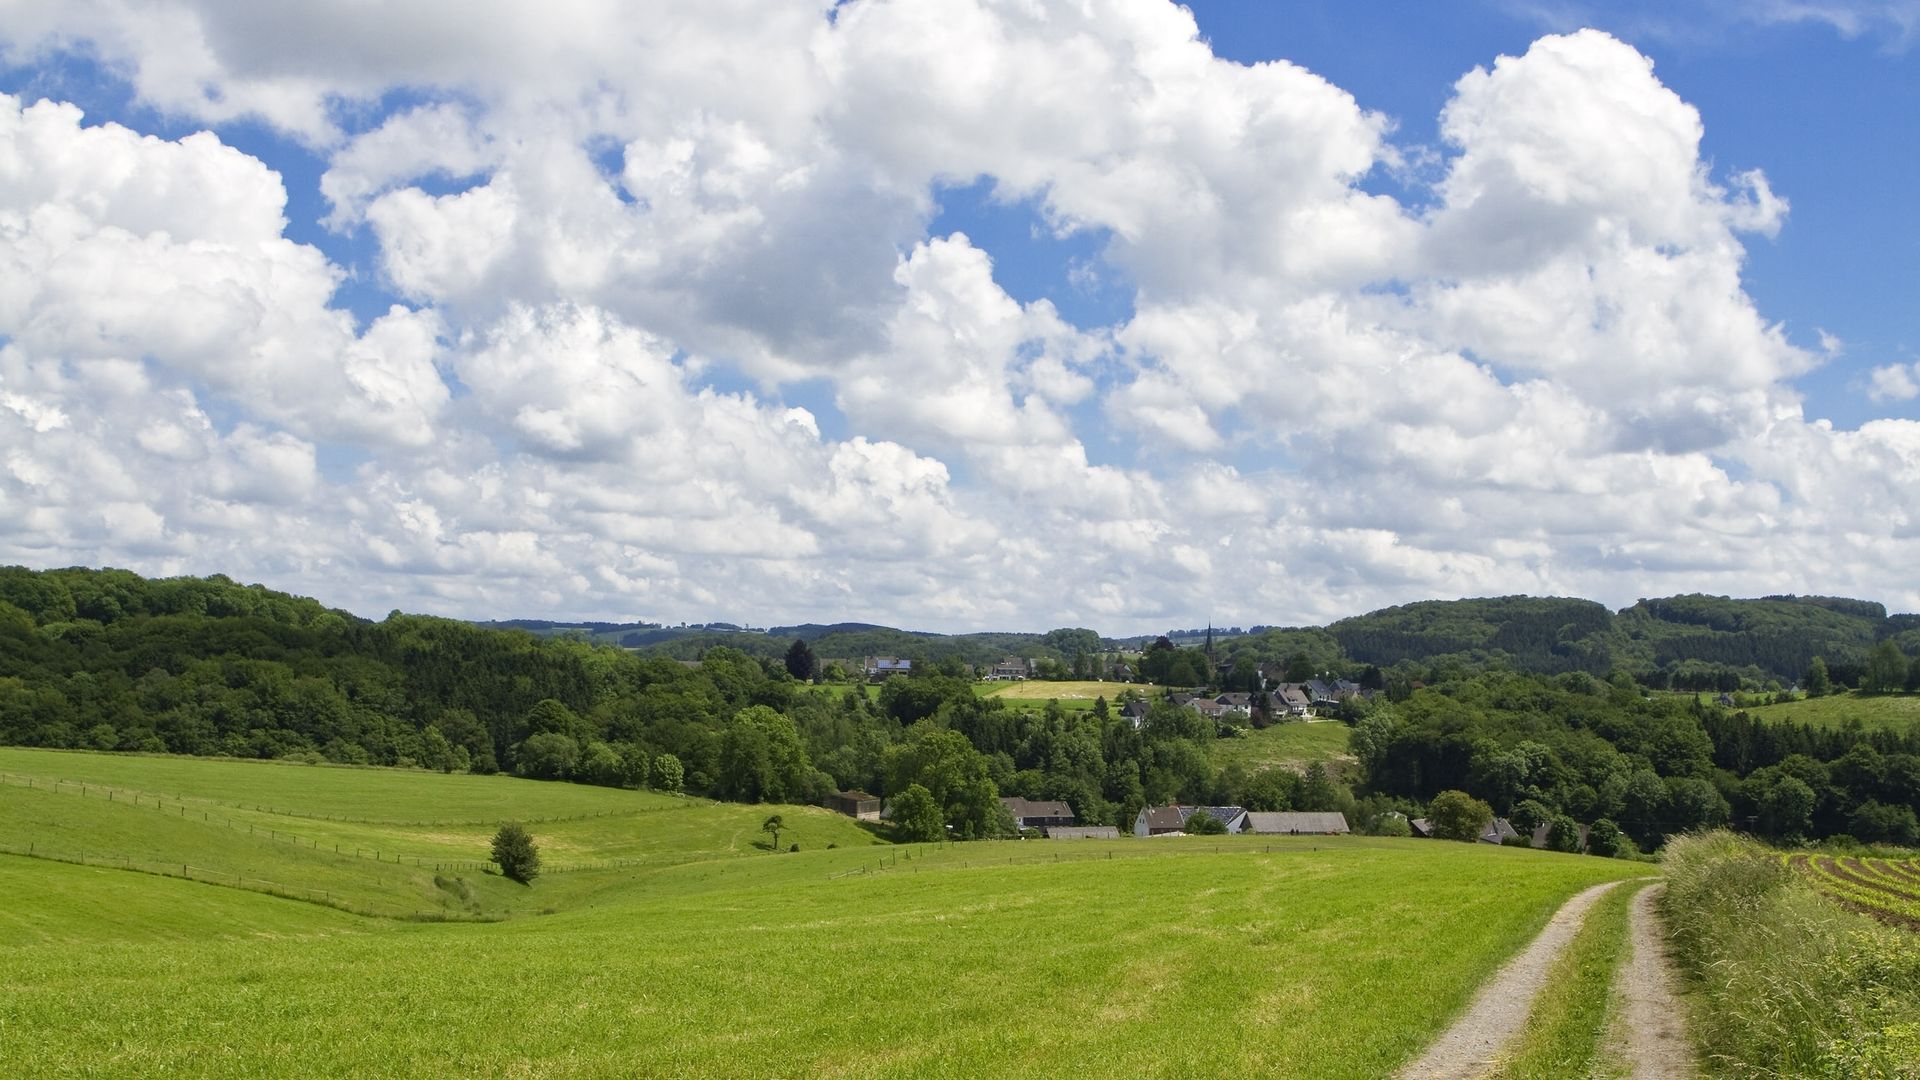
<box><xmin>0</xmin><ymin>749</ymin><xmax>1644</xmax><ymax>1078</ymax></box>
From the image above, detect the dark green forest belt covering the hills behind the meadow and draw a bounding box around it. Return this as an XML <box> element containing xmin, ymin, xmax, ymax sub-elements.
<box><xmin>0</xmin><ymin>567</ymin><xmax>1920</xmax><ymax>847</ymax></box>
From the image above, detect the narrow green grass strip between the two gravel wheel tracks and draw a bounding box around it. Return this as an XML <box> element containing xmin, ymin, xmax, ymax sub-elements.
<box><xmin>1492</xmin><ymin>882</ymin><xmax>1645</xmax><ymax>1080</ymax></box>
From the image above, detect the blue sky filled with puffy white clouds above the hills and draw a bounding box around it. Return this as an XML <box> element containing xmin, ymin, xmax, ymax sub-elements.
<box><xmin>0</xmin><ymin>0</ymin><xmax>1920</xmax><ymax>632</ymax></box>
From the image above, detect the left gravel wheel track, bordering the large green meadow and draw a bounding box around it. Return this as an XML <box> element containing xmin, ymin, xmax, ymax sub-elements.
<box><xmin>1400</xmin><ymin>882</ymin><xmax>1638</xmax><ymax>1080</ymax></box>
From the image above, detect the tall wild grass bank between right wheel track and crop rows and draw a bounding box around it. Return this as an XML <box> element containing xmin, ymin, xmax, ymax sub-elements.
<box><xmin>1663</xmin><ymin>832</ymin><xmax>1920</xmax><ymax>1080</ymax></box>
